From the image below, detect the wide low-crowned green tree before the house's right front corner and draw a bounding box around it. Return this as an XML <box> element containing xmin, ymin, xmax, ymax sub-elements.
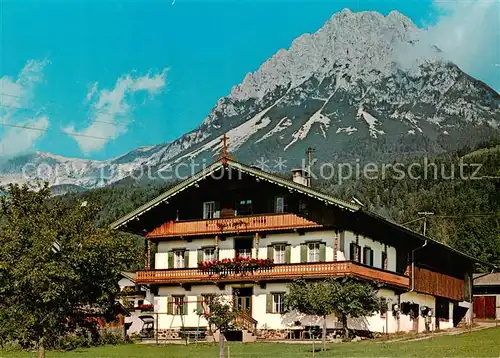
<box><xmin>285</xmin><ymin>277</ymin><xmax>379</xmax><ymax>350</ymax></box>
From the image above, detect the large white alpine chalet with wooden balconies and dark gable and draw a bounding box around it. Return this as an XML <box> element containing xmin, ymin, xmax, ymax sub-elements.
<box><xmin>112</xmin><ymin>157</ymin><xmax>475</xmax><ymax>338</ymax></box>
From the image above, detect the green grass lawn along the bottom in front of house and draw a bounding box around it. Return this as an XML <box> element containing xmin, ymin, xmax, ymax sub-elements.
<box><xmin>0</xmin><ymin>327</ymin><xmax>500</xmax><ymax>358</ymax></box>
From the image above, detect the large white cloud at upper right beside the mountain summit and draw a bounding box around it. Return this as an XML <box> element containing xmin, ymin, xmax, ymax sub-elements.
<box><xmin>399</xmin><ymin>0</ymin><xmax>500</xmax><ymax>90</ymax></box>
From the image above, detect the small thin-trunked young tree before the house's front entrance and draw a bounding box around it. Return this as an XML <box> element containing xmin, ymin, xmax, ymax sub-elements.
<box><xmin>196</xmin><ymin>295</ymin><xmax>240</xmax><ymax>358</ymax></box>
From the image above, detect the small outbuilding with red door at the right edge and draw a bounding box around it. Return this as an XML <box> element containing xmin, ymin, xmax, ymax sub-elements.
<box><xmin>473</xmin><ymin>272</ymin><xmax>500</xmax><ymax>319</ymax></box>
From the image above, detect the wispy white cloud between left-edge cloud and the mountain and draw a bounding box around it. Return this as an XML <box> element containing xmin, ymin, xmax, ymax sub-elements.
<box><xmin>64</xmin><ymin>69</ymin><xmax>167</xmax><ymax>154</ymax></box>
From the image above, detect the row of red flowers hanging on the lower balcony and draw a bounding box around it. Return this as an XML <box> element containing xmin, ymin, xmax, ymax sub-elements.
<box><xmin>198</xmin><ymin>256</ymin><xmax>274</xmax><ymax>275</ymax></box>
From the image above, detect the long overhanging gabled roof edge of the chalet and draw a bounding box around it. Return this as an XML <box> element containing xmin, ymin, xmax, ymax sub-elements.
<box><xmin>110</xmin><ymin>157</ymin><xmax>497</xmax><ymax>269</ymax></box>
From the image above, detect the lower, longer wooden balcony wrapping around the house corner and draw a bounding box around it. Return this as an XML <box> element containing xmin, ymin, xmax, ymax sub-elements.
<box><xmin>136</xmin><ymin>261</ymin><xmax>410</xmax><ymax>288</ymax></box>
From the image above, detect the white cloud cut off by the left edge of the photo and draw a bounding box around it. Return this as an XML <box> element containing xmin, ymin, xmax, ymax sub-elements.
<box><xmin>0</xmin><ymin>60</ymin><xmax>50</xmax><ymax>158</ymax></box>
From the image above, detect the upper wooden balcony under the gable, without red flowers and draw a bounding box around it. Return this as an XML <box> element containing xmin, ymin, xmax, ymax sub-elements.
<box><xmin>146</xmin><ymin>214</ymin><xmax>321</xmax><ymax>239</ymax></box>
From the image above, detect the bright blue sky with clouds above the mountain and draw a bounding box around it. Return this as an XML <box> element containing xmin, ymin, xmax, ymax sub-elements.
<box><xmin>0</xmin><ymin>0</ymin><xmax>500</xmax><ymax>159</ymax></box>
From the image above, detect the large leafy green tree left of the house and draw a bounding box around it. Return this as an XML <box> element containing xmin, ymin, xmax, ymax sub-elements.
<box><xmin>0</xmin><ymin>185</ymin><xmax>134</xmax><ymax>357</ymax></box>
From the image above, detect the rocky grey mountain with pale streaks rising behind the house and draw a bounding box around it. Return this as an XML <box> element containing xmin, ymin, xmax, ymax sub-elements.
<box><xmin>0</xmin><ymin>10</ymin><xmax>500</xmax><ymax>188</ymax></box>
